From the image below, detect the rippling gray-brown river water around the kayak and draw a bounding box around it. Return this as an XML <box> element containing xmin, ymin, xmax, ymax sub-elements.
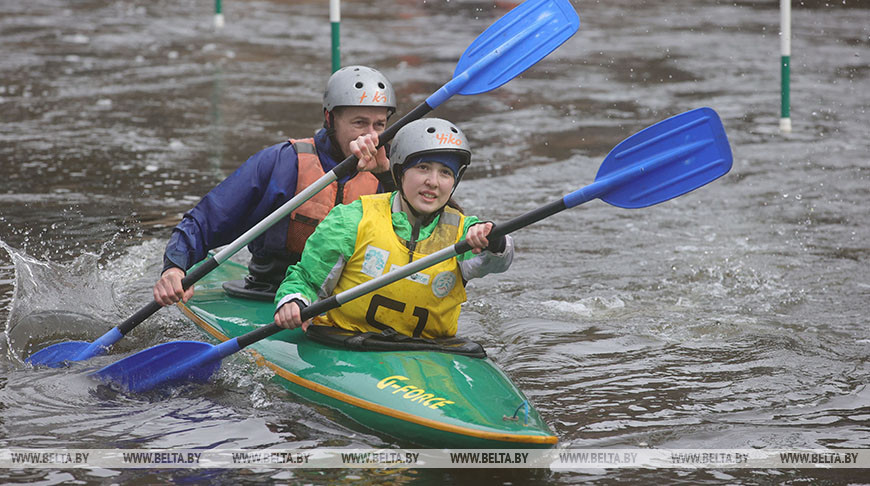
<box><xmin>0</xmin><ymin>0</ymin><xmax>870</xmax><ymax>484</ymax></box>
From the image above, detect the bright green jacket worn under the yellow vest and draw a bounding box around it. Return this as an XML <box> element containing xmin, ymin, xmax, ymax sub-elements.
<box><xmin>275</xmin><ymin>192</ymin><xmax>513</xmax><ymax>308</ymax></box>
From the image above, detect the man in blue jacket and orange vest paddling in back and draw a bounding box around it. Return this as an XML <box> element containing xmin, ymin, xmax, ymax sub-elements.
<box><xmin>153</xmin><ymin>66</ymin><xmax>396</xmax><ymax>306</ymax></box>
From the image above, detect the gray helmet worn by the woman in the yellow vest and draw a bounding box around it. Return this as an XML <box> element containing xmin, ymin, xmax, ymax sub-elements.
<box><xmin>390</xmin><ymin>118</ymin><xmax>471</xmax><ymax>189</ymax></box>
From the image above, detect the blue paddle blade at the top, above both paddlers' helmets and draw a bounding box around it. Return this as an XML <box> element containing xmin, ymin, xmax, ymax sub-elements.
<box><xmin>454</xmin><ymin>0</ymin><xmax>580</xmax><ymax>96</ymax></box>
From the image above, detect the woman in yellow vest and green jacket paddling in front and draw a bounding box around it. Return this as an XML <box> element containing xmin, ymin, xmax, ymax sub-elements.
<box><xmin>275</xmin><ymin>118</ymin><xmax>514</xmax><ymax>338</ymax></box>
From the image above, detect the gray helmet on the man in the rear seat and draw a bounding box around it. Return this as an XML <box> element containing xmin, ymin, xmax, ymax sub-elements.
<box><xmin>323</xmin><ymin>66</ymin><xmax>396</xmax><ymax>115</ymax></box>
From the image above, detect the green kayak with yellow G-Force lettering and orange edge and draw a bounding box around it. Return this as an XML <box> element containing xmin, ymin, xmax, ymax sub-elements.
<box><xmin>180</xmin><ymin>262</ymin><xmax>558</xmax><ymax>449</ymax></box>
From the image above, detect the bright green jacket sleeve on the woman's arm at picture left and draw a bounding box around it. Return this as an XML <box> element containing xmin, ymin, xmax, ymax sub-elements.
<box><xmin>275</xmin><ymin>199</ymin><xmax>363</xmax><ymax>305</ymax></box>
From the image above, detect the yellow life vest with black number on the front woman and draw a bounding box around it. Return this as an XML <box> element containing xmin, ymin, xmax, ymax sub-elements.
<box><xmin>314</xmin><ymin>194</ymin><xmax>466</xmax><ymax>338</ymax></box>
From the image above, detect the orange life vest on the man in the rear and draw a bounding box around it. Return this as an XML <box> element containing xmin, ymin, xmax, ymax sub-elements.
<box><xmin>287</xmin><ymin>138</ymin><xmax>378</xmax><ymax>254</ymax></box>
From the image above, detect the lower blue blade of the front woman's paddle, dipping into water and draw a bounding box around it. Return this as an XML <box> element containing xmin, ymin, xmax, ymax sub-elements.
<box><xmin>91</xmin><ymin>341</ymin><xmax>221</xmax><ymax>393</ymax></box>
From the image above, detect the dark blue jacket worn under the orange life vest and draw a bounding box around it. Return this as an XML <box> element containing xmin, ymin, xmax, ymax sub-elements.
<box><xmin>163</xmin><ymin>129</ymin><xmax>389</xmax><ymax>271</ymax></box>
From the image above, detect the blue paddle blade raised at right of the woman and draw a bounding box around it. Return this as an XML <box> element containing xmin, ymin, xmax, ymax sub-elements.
<box><xmin>590</xmin><ymin>108</ymin><xmax>732</xmax><ymax>208</ymax></box>
